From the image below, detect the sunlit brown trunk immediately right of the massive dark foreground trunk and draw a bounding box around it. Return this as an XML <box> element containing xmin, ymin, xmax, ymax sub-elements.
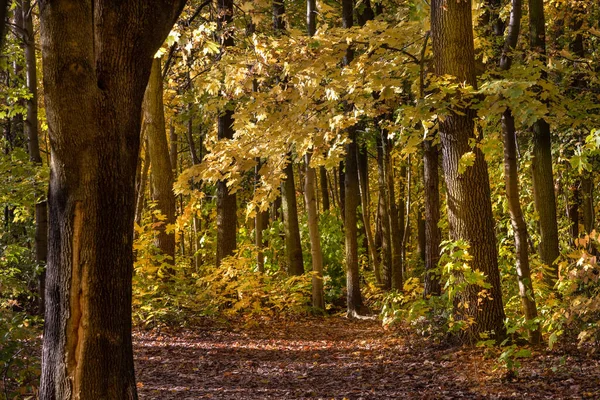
<box><xmin>142</xmin><ymin>58</ymin><xmax>175</xmax><ymax>266</ymax></box>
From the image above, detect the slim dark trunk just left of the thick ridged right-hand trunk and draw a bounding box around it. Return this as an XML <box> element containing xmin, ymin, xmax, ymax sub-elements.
<box><xmin>423</xmin><ymin>140</ymin><xmax>442</xmax><ymax>296</ymax></box>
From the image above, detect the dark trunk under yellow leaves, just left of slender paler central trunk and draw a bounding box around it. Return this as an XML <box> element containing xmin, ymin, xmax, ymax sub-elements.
<box><xmin>281</xmin><ymin>156</ymin><xmax>304</xmax><ymax>275</ymax></box>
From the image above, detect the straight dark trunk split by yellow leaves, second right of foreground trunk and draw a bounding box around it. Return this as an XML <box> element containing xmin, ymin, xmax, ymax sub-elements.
<box><xmin>216</xmin><ymin>0</ymin><xmax>237</xmax><ymax>265</ymax></box>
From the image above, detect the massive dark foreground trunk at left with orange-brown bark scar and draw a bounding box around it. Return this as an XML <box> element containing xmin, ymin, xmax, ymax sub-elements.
<box><xmin>40</xmin><ymin>0</ymin><xmax>183</xmax><ymax>400</ymax></box>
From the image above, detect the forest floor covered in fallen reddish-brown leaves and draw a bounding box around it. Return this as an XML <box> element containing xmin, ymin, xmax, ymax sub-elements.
<box><xmin>134</xmin><ymin>317</ymin><xmax>600</xmax><ymax>400</ymax></box>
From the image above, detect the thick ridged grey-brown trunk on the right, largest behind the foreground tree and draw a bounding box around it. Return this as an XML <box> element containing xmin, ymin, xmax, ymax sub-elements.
<box><xmin>431</xmin><ymin>0</ymin><xmax>505</xmax><ymax>340</ymax></box>
